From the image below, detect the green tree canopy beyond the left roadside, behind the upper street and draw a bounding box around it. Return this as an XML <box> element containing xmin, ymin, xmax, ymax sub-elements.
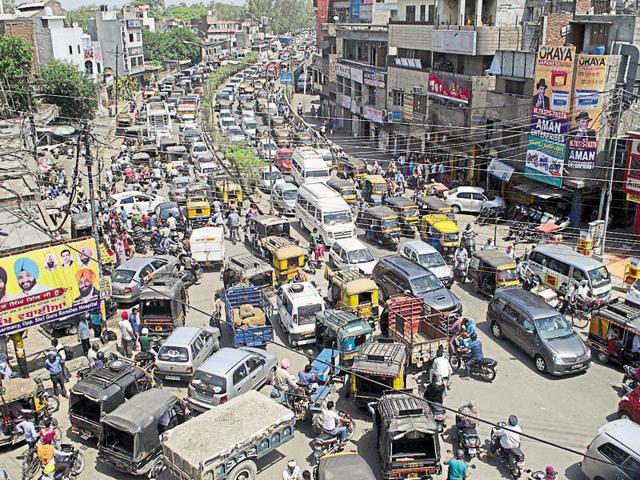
<box><xmin>142</xmin><ymin>28</ymin><xmax>201</xmax><ymax>63</ymax></box>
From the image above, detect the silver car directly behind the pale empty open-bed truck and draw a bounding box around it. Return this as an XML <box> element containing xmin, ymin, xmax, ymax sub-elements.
<box><xmin>188</xmin><ymin>347</ymin><xmax>278</xmax><ymax>412</ymax></box>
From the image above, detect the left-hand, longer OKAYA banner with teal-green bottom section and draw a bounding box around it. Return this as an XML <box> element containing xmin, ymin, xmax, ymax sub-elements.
<box><xmin>524</xmin><ymin>46</ymin><xmax>575</xmax><ymax>187</ymax></box>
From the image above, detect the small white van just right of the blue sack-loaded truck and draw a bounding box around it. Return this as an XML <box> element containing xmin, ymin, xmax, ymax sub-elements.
<box><xmin>278</xmin><ymin>282</ymin><xmax>324</xmax><ymax>347</ymax></box>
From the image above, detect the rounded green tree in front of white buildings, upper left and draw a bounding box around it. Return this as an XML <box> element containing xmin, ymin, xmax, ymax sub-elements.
<box><xmin>38</xmin><ymin>60</ymin><xmax>98</xmax><ymax>119</ymax></box>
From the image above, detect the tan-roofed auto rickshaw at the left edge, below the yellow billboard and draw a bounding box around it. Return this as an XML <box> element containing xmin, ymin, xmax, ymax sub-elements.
<box><xmin>0</xmin><ymin>378</ymin><xmax>60</xmax><ymax>446</ymax></box>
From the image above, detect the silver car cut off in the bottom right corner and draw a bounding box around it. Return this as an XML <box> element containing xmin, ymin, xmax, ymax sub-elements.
<box><xmin>581</xmin><ymin>419</ymin><xmax>640</xmax><ymax>480</ymax></box>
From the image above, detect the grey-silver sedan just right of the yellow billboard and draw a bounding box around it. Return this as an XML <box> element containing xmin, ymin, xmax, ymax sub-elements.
<box><xmin>111</xmin><ymin>255</ymin><xmax>180</xmax><ymax>303</ymax></box>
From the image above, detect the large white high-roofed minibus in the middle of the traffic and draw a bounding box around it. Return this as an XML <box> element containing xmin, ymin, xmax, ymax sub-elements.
<box><xmin>296</xmin><ymin>183</ymin><xmax>357</xmax><ymax>246</ymax></box>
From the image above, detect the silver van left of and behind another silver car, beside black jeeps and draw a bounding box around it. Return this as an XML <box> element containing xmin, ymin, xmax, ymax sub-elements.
<box><xmin>155</xmin><ymin>327</ymin><xmax>220</xmax><ymax>382</ymax></box>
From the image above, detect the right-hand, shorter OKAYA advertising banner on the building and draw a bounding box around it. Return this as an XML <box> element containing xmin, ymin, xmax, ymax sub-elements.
<box><xmin>567</xmin><ymin>54</ymin><xmax>609</xmax><ymax>170</ymax></box>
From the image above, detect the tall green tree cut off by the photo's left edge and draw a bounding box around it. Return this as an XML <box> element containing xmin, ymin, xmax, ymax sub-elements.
<box><xmin>0</xmin><ymin>35</ymin><xmax>33</xmax><ymax>110</ymax></box>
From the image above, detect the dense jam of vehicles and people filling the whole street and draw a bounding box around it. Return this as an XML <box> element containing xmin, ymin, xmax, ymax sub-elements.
<box><xmin>0</xmin><ymin>32</ymin><xmax>640</xmax><ymax>480</ymax></box>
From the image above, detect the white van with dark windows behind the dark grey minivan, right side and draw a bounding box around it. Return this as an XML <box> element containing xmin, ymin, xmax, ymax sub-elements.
<box><xmin>529</xmin><ymin>245</ymin><xmax>611</xmax><ymax>301</ymax></box>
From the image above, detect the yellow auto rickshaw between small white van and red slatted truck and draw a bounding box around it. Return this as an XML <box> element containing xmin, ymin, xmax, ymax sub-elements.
<box><xmin>326</xmin><ymin>269</ymin><xmax>380</xmax><ymax>326</ymax></box>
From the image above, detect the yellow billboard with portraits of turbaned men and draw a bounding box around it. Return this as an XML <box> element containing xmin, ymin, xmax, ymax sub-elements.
<box><xmin>0</xmin><ymin>238</ymin><xmax>100</xmax><ymax>334</ymax></box>
